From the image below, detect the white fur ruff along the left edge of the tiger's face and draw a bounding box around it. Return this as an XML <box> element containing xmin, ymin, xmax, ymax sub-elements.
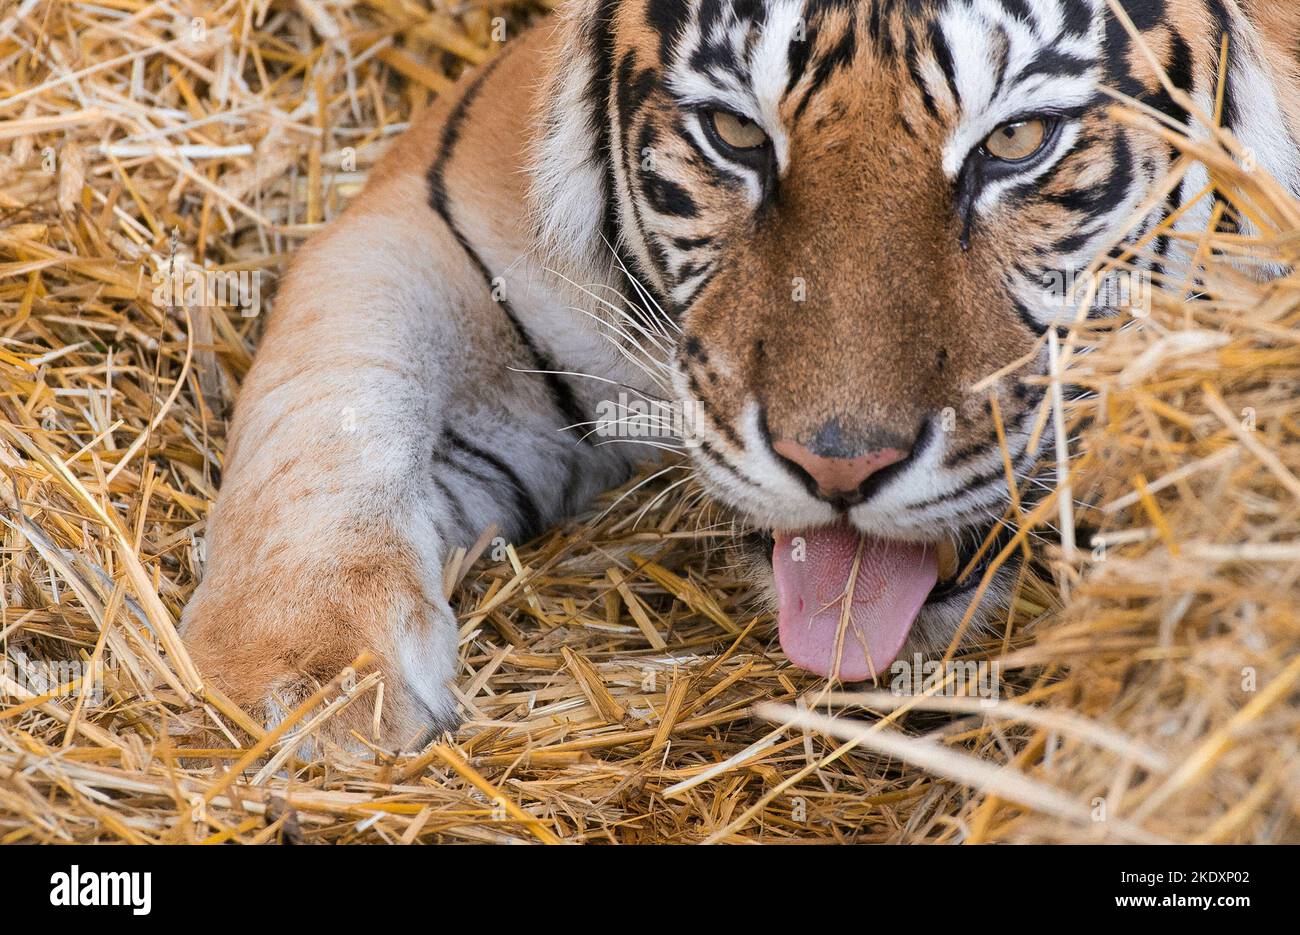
<box><xmin>528</xmin><ymin>0</ymin><xmax>611</xmax><ymax>274</ymax></box>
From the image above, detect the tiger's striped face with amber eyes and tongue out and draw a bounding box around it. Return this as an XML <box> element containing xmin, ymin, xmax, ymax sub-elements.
<box><xmin>538</xmin><ymin>0</ymin><xmax>1296</xmax><ymax>680</ymax></box>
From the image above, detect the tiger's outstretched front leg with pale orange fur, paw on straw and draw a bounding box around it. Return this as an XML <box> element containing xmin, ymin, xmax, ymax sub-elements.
<box><xmin>183</xmin><ymin>206</ymin><xmax>577</xmax><ymax>746</ymax></box>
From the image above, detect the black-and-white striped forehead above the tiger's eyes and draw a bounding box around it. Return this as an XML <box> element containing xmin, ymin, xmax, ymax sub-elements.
<box><xmin>625</xmin><ymin>0</ymin><xmax>1104</xmax><ymax>161</ymax></box>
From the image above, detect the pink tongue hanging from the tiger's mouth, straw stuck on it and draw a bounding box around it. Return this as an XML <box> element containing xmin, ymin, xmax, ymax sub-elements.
<box><xmin>772</xmin><ymin>525</ymin><xmax>939</xmax><ymax>681</ymax></box>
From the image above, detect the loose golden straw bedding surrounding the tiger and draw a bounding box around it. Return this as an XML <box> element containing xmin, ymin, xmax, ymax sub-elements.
<box><xmin>0</xmin><ymin>0</ymin><xmax>1300</xmax><ymax>843</ymax></box>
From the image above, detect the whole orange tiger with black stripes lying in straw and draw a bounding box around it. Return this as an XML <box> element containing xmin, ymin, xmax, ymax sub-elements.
<box><xmin>182</xmin><ymin>0</ymin><xmax>1300</xmax><ymax>745</ymax></box>
